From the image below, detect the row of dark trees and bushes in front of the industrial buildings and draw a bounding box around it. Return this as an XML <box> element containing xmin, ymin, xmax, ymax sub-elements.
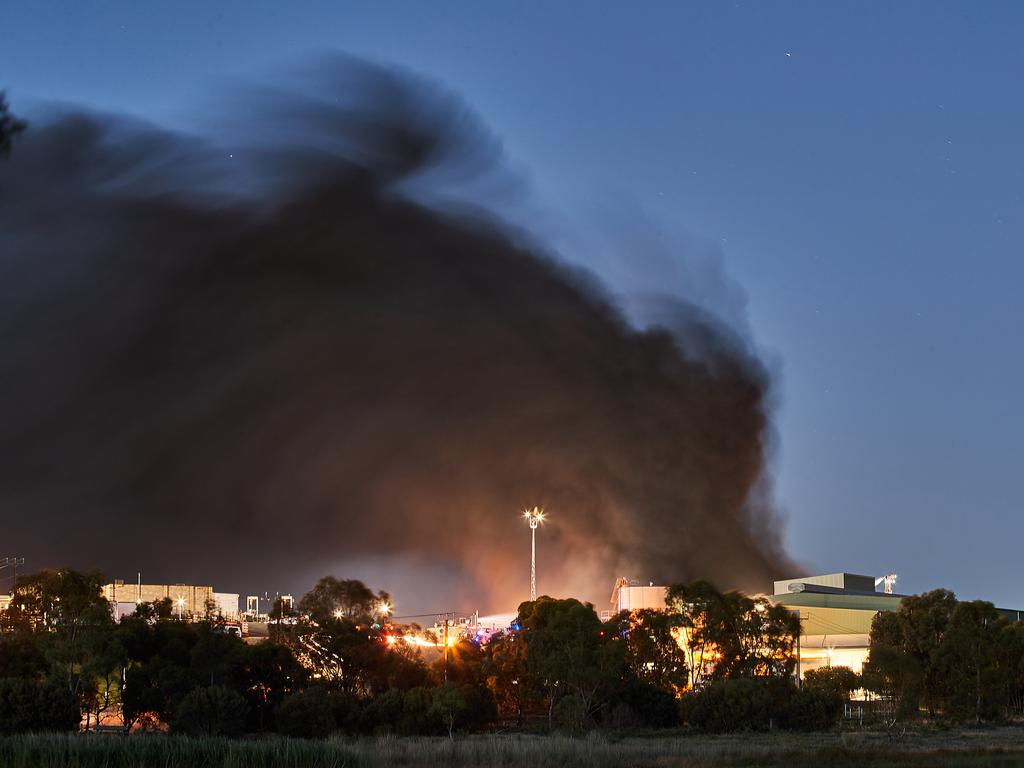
<box><xmin>0</xmin><ymin>570</ymin><xmax>1024</xmax><ymax>737</ymax></box>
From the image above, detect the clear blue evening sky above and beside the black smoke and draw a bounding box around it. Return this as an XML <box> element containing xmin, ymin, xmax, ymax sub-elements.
<box><xmin>0</xmin><ymin>0</ymin><xmax>1024</xmax><ymax>608</ymax></box>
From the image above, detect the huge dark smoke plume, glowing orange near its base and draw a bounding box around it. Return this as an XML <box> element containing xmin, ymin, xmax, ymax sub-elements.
<box><xmin>0</xmin><ymin>60</ymin><xmax>788</xmax><ymax>608</ymax></box>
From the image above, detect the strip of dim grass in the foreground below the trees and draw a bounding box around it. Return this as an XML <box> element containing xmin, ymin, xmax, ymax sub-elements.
<box><xmin>0</xmin><ymin>727</ymin><xmax>1024</xmax><ymax>768</ymax></box>
